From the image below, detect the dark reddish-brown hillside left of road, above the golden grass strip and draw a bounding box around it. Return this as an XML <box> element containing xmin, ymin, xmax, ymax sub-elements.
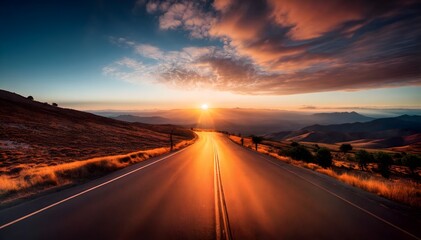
<box><xmin>0</xmin><ymin>90</ymin><xmax>194</xmax><ymax>173</ymax></box>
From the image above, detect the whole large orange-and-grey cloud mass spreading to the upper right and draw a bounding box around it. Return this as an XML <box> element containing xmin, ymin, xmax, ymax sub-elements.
<box><xmin>115</xmin><ymin>0</ymin><xmax>421</xmax><ymax>95</ymax></box>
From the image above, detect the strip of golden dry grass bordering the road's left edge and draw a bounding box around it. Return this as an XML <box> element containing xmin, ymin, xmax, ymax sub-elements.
<box><xmin>0</xmin><ymin>139</ymin><xmax>195</xmax><ymax>203</ymax></box>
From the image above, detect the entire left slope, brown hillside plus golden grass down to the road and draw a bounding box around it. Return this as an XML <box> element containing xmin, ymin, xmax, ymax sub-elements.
<box><xmin>0</xmin><ymin>90</ymin><xmax>195</xmax><ymax>205</ymax></box>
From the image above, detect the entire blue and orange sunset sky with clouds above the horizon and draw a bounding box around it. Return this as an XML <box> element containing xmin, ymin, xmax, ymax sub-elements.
<box><xmin>0</xmin><ymin>0</ymin><xmax>421</xmax><ymax>110</ymax></box>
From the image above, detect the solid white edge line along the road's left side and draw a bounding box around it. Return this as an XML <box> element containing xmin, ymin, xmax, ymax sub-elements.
<box><xmin>0</xmin><ymin>148</ymin><xmax>187</xmax><ymax>230</ymax></box>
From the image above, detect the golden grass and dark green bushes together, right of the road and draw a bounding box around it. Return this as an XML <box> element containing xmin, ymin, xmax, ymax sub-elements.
<box><xmin>229</xmin><ymin>135</ymin><xmax>421</xmax><ymax>208</ymax></box>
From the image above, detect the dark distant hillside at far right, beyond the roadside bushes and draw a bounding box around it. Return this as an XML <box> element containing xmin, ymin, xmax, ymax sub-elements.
<box><xmin>266</xmin><ymin>115</ymin><xmax>421</xmax><ymax>149</ymax></box>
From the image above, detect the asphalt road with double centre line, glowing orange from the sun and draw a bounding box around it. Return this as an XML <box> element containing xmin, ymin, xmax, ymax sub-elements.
<box><xmin>0</xmin><ymin>133</ymin><xmax>421</xmax><ymax>239</ymax></box>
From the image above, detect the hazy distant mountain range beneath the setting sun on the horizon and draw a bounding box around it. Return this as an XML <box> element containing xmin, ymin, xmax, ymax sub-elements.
<box><xmin>103</xmin><ymin>108</ymin><xmax>373</xmax><ymax>135</ymax></box>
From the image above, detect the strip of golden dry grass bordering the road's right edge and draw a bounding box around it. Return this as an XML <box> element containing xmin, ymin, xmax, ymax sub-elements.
<box><xmin>229</xmin><ymin>136</ymin><xmax>421</xmax><ymax>208</ymax></box>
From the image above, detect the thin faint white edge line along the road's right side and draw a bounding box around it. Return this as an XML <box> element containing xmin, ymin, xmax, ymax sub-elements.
<box><xmin>259</xmin><ymin>156</ymin><xmax>421</xmax><ymax>240</ymax></box>
